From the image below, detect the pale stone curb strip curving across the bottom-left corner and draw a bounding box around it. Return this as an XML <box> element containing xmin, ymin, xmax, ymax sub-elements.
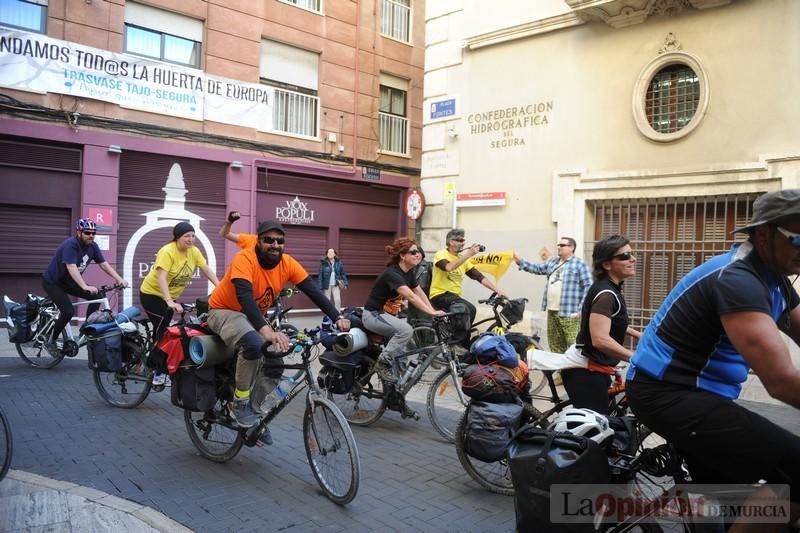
<box><xmin>6</xmin><ymin>470</ymin><xmax>193</xmax><ymax>533</ymax></box>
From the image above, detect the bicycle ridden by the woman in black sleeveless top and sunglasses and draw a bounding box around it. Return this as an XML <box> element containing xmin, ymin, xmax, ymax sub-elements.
<box><xmin>455</xmin><ymin>369</ymin><xmax>636</xmax><ymax>496</ymax></box>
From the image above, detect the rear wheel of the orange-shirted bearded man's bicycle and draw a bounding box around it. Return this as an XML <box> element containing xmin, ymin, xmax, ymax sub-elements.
<box><xmin>183</xmin><ymin>401</ymin><xmax>244</xmax><ymax>463</ymax></box>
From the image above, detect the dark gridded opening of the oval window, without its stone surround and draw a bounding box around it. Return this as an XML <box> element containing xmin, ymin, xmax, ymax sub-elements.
<box><xmin>644</xmin><ymin>64</ymin><xmax>700</xmax><ymax>133</ymax></box>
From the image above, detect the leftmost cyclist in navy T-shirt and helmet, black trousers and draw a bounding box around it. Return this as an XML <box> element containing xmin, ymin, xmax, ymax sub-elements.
<box><xmin>42</xmin><ymin>218</ymin><xmax>128</xmax><ymax>354</ymax></box>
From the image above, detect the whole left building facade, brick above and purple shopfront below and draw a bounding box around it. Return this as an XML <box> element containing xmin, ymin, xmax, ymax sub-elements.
<box><xmin>0</xmin><ymin>0</ymin><xmax>424</xmax><ymax>308</ymax></box>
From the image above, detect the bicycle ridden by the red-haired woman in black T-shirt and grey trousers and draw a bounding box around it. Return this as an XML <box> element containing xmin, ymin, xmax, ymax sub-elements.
<box><xmin>320</xmin><ymin>313</ymin><xmax>468</xmax><ymax>442</ymax></box>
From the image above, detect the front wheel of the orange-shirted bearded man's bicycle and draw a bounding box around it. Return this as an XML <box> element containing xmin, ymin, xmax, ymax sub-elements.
<box><xmin>303</xmin><ymin>397</ymin><xmax>360</xmax><ymax>505</ymax></box>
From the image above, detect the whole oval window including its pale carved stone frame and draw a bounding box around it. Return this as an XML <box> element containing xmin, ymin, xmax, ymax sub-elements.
<box><xmin>633</xmin><ymin>51</ymin><xmax>709</xmax><ymax>142</ymax></box>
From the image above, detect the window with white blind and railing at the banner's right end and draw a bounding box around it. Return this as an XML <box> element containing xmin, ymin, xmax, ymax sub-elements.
<box><xmin>260</xmin><ymin>39</ymin><xmax>319</xmax><ymax>138</ymax></box>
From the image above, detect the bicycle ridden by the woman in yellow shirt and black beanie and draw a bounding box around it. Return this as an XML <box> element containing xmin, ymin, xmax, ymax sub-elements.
<box><xmin>93</xmin><ymin>303</ymin><xmax>201</xmax><ymax>409</ymax></box>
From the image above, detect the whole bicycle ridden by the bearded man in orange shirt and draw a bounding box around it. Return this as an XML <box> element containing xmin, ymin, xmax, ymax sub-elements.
<box><xmin>184</xmin><ymin>328</ymin><xmax>361</xmax><ymax>505</ymax></box>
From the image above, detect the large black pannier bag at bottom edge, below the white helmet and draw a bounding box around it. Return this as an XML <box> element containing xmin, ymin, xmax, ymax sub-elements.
<box><xmin>508</xmin><ymin>425</ymin><xmax>611</xmax><ymax>533</ymax></box>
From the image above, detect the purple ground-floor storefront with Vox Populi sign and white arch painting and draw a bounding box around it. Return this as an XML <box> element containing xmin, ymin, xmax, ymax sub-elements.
<box><xmin>0</xmin><ymin>119</ymin><xmax>411</xmax><ymax>309</ymax></box>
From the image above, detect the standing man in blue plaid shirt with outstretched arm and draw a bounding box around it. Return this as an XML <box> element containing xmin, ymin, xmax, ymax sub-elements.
<box><xmin>514</xmin><ymin>237</ymin><xmax>592</xmax><ymax>353</ymax></box>
